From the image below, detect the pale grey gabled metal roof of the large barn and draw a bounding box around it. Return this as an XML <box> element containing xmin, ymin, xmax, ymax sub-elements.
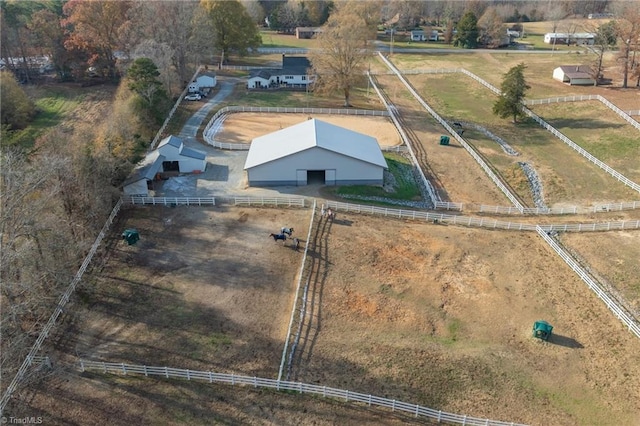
<box><xmin>244</xmin><ymin>118</ymin><xmax>387</xmax><ymax>169</ymax></box>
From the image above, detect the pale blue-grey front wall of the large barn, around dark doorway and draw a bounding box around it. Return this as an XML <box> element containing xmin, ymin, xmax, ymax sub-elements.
<box><xmin>247</xmin><ymin>148</ymin><xmax>384</xmax><ymax>185</ymax></box>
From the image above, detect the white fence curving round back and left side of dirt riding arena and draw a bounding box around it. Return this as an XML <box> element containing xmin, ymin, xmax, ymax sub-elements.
<box><xmin>202</xmin><ymin>106</ymin><xmax>389</xmax><ymax>151</ymax></box>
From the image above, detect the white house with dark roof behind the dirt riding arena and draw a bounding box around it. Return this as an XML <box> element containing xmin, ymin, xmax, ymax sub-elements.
<box><xmin>247</xmin><ymin>55</ymin><xmax>313</xmax><ymax>89</ymax></box>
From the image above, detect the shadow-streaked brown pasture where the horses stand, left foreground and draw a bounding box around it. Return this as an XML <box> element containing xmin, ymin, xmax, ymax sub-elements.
<box><xmin>61</xmin><ymin>206</ymin><xmax>309</xmax><ymax>376</ymax></box>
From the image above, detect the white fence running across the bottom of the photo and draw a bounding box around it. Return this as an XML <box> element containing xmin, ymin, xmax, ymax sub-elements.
<box><xmin>80</xmin><ymin>360</ymin><xmax>521</xmax><ymax>426</ymax></box>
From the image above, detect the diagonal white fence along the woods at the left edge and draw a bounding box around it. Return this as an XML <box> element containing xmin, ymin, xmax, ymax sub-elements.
<box><xmin>0</xmin><ymin>200</ymin><xmax>122</xmax><ymax>414</ymax></box>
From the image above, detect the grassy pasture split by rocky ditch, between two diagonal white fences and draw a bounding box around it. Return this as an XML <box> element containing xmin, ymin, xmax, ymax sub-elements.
<box><xmin>408</xmin><ymin>73</ymin><xmax>638</xmax><ymax>206</ymax></box>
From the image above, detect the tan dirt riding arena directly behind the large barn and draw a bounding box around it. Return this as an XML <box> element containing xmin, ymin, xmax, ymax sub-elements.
<box><xmin>216</xmin><ymin>113</ymin><xmax>402</xmax><ymax>146</ymax></box>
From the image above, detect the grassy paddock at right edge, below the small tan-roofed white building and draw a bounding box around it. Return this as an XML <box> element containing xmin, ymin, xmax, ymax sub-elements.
<box><xmin>530</xmin><ymin>100</ymin><xmax>640</xmax><ymax>182</ymax></box>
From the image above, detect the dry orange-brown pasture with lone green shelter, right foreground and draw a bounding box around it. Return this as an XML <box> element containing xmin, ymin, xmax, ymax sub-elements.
<box><xmin>294</xmin><ymin>210</ymin><xmax>640</xmax><ymax>425</ymax></box>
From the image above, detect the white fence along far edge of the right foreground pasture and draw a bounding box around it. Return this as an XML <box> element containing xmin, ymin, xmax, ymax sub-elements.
<box><xmin>324</xmin><ymin>200</ymin><xmax>640</xmax><ymax>232</ymax></box>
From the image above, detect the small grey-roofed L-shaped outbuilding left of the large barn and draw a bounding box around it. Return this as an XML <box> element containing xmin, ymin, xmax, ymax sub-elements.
<box><xmin>124</xmin><ymin>136</ymin><xmax>207</xmax><ymax>196</ymax></box>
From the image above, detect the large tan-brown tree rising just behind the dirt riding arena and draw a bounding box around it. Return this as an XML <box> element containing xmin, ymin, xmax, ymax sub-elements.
<box><xmin>309</xmin><ymin>2</ymin><xmax>370</xmax><ymax>107</ymax></box>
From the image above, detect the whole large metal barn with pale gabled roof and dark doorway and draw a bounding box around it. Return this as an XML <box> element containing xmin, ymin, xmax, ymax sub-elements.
<box><xmin>244</xmin><ymin>119</ymin><xmax>387</xmax><ymax>186</ymax></box>
